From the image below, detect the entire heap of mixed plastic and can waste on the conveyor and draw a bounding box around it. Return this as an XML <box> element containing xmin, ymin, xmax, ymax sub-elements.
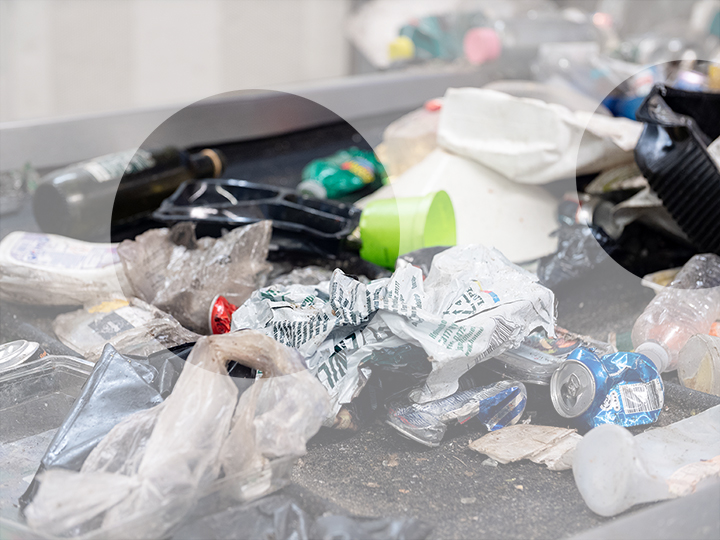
<box><xmin>0</xmin><ymin>4</ymin><xmax>720</xmax><ymax>540</ymax></box>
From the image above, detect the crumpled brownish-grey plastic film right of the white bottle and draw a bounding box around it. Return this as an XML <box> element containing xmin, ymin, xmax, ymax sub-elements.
<box><xmin>118</xmin><ymin>221</ymin><xmax>272</xmax><ymax>334</ymax></box>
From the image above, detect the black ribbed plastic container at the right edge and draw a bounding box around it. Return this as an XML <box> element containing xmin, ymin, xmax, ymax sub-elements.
<box><xmin>635</xmin><ymin>84</ymin><xmax>720</xmax><ymax>254</ymax></box>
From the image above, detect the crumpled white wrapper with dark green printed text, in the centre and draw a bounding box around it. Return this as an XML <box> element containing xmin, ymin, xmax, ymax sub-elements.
<box><xmin>232</xmin><ymin>245</ymin><xmax>554</xmax><ymax>420</ymax></box>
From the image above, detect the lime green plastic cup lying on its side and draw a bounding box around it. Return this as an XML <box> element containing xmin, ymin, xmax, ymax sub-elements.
<box><xmin>360</xmin><ymin>191</ymin><xmax>456</xmax><ymax>269</ymax></box>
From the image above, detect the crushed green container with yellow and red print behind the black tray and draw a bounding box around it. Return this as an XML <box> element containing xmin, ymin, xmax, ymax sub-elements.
<box><xmin>297</xmin><ymin>147</ymin><xmax>387</xmax><ymax>199</ymax></box>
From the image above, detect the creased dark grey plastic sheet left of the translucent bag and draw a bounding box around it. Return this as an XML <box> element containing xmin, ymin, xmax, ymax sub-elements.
<box><xmin>20</xmin><ymin>344</ymin><xmax>192</xmax><ymax>508</ymax></box>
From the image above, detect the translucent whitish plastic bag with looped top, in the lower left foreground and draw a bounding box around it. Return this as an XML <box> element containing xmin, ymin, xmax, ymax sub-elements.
<box><xmin>25</xmin><ymin>332</ymin><xmax>329</xmax><ymax>538</ymax></box>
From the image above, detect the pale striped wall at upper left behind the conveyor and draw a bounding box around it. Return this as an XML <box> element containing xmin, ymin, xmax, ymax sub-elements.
<box><xmin>0</xmin><ymin>0</ymin><xmax>351</xmax><ymax>122</ymax></box>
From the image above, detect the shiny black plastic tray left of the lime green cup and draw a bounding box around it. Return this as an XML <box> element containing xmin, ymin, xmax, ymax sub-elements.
<box><xmin>153</xmin><ymin>179</ymin><xmax>361</xmax><ymax>254</ymax></box>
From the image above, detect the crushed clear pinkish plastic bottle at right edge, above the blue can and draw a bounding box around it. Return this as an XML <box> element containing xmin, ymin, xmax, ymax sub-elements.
<box><xmin>632</xmin><ymin>253</ymin><xmax>720</xmax><ymax>371</ymax></box>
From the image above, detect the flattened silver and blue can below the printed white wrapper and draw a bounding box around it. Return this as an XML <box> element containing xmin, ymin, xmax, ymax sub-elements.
<box><xmin>386</xmin><ymin>381</ymin><xmax>527</xmax><ymax>447</ymax></box>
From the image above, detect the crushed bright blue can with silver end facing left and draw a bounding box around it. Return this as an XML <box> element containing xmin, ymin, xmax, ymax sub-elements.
<box><xmin>550</xmin><ymin>348</ymin><xmax>664</xmax><ymax>428</ymax></box>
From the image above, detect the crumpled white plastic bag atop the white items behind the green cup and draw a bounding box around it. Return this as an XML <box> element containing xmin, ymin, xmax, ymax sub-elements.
<box><xmin>437</xmin><ymin>88</ymin><xmax>642</xmax><ymax>184</ymax></box>
